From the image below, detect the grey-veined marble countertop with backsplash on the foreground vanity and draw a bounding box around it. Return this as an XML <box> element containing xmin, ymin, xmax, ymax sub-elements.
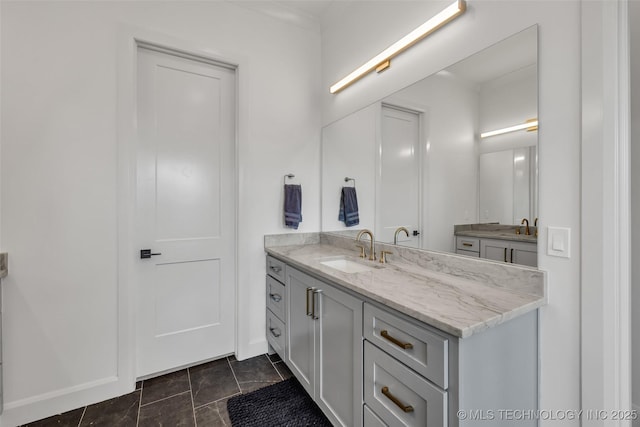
<box><xmin>265</xmin><ymin>240</ymin><xmax>546</xmax><ymax>338</ymax></box>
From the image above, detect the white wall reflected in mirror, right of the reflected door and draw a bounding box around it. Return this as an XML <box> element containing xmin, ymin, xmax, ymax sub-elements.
<box><xmin>390</xmin><ymin>74</ymin><xmax>478</xmax><ymax>252</ymax></box>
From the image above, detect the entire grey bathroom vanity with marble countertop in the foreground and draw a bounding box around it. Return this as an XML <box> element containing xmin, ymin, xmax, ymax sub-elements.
<box><xmin>265</xmin><ymin>233</ymin><xmax>546</xmax><ymax>427</ymax></box>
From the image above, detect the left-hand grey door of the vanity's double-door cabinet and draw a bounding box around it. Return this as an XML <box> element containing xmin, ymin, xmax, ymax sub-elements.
<box><xmin>285</xmin><ymin>268</ymin><xmax>317</xmax><ymax>397</ymax></box>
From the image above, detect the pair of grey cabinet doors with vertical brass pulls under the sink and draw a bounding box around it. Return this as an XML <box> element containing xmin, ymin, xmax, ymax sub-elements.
<box><xmin>284</xmin><ymin>266</ymin><xmax>362</xmax><ymax>427</ymax></box>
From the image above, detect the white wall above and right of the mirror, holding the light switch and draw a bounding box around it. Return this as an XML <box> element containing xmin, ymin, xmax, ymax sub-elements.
<box><xmin>322</xmin><ymin>0</ymin><xmax>581</xmax><ymax>425</ymax></box>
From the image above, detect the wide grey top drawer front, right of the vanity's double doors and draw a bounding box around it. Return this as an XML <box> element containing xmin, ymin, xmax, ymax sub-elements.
<box><xmin>364</xmin><ymin>303</ymin><xmax>449</xmax><ymax>390</ymax></box>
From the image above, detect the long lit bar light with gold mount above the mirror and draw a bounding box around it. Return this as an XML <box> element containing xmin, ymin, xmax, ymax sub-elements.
<box><xmin>329</xmin><ymin>0</ymin><xmax>467</xmax><ymax>93</ymax></box>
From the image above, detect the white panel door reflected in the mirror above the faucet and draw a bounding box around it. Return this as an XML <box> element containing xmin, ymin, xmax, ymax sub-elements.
<box><xmin>376</xmin><ymin>106</ymin><xmax>421</xmax><ymax>247</ymax></box>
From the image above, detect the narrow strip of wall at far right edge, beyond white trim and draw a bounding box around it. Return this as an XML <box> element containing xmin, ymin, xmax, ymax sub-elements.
<box><xmin>629</xmin><ymin>1</ymin><xmax>640</xmax><ymax>427</ymax></box>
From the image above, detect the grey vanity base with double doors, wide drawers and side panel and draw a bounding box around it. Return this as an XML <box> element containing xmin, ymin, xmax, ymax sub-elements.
<box><xmin>267</xmin><ymin>254</ymin><xmax>538</xmax><ymax>427</ymax></box>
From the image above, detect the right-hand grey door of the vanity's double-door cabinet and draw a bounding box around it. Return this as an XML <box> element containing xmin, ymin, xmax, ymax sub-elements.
<box><xmin>314</xmin><ymin>283</ymin><xmax>362</xmax><ymax>427</ymax></box>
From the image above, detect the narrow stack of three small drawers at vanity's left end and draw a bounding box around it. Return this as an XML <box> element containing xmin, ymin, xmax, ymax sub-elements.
<box><xmin>267</xmin><ymin>256</ymin><xmax>286</xmax><ymax>360</ymax></box>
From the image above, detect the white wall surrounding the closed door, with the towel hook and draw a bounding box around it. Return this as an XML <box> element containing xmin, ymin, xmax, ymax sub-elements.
<box><xmin>0</xmin><ymin>1</ymin><xmax>321</xmax><ymax>426</ymax></box>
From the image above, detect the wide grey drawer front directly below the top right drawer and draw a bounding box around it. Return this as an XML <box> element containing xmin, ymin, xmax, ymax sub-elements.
<box><xmin>364</xmin><ymin>341</ymin><xmax>447</xmax><ymax>427</ymax></box>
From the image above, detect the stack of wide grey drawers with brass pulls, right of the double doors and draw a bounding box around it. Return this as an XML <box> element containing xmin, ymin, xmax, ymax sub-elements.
<box><xmin>363</xmin><ymin>303</ymin><xmax>449</xmax><ymax>427</ymax></box>
